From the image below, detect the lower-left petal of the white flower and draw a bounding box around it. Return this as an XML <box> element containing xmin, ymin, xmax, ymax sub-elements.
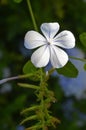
<box><xmin>31</xmin><ymin>45</ymin><xmax>50</xmax><ymax>68</ymax></box>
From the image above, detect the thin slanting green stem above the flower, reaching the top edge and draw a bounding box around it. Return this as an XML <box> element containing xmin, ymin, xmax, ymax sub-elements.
<box><xmin>27</xmin><ymin>0</ymin><xmax>38</xmax><ymax>31</ymax></box>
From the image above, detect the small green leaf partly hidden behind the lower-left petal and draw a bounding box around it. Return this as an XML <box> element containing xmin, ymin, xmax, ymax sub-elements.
<box><xmin>23</xmin><ymin>61</ymin><xmax>37</xmax><ymax>74</ymax></box>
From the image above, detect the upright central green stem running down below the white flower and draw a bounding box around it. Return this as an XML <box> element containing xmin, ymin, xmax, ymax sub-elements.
<box><xmin>39</xmin><ymin>68</ymin><xmax>55</xmax><ymax>130</ymax></box>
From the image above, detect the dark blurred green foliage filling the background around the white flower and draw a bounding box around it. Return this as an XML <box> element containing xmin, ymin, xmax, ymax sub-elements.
<box><xmin>0</xmin><ymin>0</ymin><xmax>86</xmax><ymax>130</ymax></box>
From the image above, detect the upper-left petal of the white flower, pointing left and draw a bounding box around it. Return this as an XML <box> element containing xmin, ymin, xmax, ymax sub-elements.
<box><xmin>24</xmin><ymin>31</ymin><xmax>46</xmax><ymax>49</ymax></box>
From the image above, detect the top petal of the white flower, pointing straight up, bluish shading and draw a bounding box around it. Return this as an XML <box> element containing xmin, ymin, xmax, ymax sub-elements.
<box><xmin>41</xmin><ymin>22</ymin><xmax>59</xmax><ymax>40</ymax></box>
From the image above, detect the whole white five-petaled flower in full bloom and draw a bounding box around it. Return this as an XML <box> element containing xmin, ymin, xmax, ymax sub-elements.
<box><xmin>24</xmin><ymin>22</ymin><xmax>75</xmax><ymax>68</ymax></box>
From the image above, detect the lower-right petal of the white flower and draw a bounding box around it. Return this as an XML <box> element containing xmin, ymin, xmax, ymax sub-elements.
<box><xmin>50</xmin><ymin>45</ymin><xmax>68</xmax><ymax>68</ymax></box>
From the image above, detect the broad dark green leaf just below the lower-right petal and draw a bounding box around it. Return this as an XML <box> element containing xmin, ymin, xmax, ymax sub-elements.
<box><xmin>56</xmin><ymin>61</ymin><xmax>78</xmax><ymax>78</ymax></box>
